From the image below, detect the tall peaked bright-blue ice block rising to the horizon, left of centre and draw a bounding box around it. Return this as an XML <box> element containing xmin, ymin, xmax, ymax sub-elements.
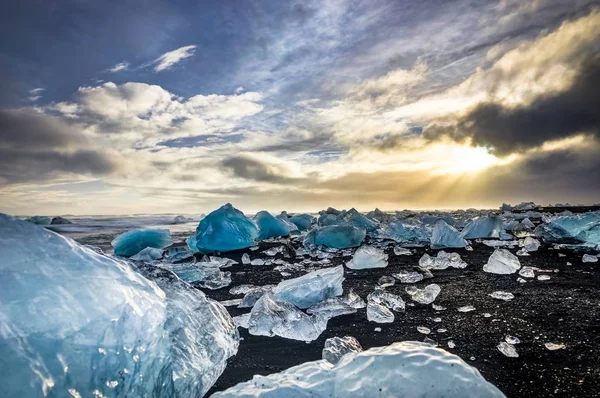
<box><xmin>188</xmin><ymin>203</ymin><xmax>258</xmax><ymax>254</ymax></box>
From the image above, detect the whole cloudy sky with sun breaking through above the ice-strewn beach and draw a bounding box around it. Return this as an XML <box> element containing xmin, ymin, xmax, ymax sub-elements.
<box><xmin>0</xmin><ymin>0</ymin><xmax>600</xmax><ymax>215</ymax></box>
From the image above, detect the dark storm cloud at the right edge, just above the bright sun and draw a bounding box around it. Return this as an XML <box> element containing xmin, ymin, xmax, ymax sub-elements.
<box><xmin>424</xmin><ymin>53</ymin><xmax>600</xmax><ymax>155</ymax></box>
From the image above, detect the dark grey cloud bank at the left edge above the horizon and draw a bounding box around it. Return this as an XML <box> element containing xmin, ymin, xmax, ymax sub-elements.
<box><xmin>0</xmin><ymin>110</ymin><xmax>117</xmax><ymax>183</ymax></box>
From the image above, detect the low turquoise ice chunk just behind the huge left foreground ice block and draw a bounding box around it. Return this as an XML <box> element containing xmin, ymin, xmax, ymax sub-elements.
<box><xmin>110</xmin><ymin>229</ymin><xmax>173</xmax><ymax>257</ymax></box>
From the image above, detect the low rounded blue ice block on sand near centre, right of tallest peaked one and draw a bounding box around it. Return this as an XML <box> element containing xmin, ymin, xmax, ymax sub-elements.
<box><xmin>304</xmin><ymin>225</ymin><xmax>366</xmax><ymax>250</ymax></box>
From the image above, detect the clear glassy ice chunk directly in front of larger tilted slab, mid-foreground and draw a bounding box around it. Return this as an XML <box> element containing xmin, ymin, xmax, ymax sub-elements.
<box><xmin>248</xmin><ymin>293</ymin><xmax>327</xmax><ymax>342</ymax></box>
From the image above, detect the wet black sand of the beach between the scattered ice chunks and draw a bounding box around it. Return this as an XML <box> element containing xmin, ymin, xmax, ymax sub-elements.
<box><xmin>203</xmin><ymin>242</ymin><xmax>600</xmax><ymax>397</ymax></box>
